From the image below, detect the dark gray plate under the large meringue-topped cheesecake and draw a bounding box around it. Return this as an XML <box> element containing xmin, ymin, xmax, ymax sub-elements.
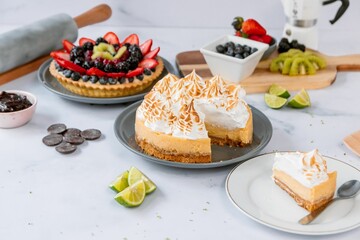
<box><xmin>114</xmin><ymin>101</ymin><xmax>272</xmax><ymax>168</ymax></box>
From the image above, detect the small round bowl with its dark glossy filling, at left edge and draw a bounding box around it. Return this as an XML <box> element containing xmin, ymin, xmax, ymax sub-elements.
<box><xmin>0</xmin><ymin>90</ymin><xmax>37</xmax><ymax>128</ymax></box>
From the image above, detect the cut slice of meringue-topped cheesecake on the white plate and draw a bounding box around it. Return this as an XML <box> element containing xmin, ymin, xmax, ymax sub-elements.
<box><xmin>272</xmin><ymin>149</ymin><xmax>337</xmax><ymax>212</ymax></box>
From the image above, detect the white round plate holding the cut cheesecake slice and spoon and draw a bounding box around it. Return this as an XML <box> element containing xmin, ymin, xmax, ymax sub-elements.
<box><xmin>225</xmin><ymin>153</ymin><xmax>360</xmax><ymax>235</ymax></box>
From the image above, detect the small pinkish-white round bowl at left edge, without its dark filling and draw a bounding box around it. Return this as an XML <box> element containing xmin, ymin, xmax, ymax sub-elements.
<box><xmin>0</xmin><ymin>90</ymin><xmax>37</xmax><ymax>128</ymax></box>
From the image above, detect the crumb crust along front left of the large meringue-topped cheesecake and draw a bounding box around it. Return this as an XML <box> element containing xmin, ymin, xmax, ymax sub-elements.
<box><xmin>135</xmin><ymin>137</ymin><xmax>211</xmax><ymax>163</ymax></box>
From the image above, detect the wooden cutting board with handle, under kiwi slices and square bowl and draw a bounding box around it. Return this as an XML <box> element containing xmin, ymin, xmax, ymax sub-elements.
<box><xmin>176</xmin><ymin>51</ymin><xmax>360</xmax><ymax>93</ymax></box>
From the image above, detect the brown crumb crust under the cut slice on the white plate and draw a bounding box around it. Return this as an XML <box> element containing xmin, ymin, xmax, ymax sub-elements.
<box><xmin>274</xmin><ymin>177</ymin><xmax>333</xmax><ymax>212</ymax></box>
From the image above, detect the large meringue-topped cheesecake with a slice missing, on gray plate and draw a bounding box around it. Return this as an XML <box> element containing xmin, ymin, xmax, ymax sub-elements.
<box><xmin>135</xmin><ymin>71</ymin><xmax>253</xmax><ymax>163</ymax></box>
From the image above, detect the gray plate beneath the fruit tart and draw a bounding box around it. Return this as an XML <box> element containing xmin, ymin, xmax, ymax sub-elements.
<box><xmin>37</xmin><ymin>58</ymin><xmax>175</xmax><ymax>104</ymax></box>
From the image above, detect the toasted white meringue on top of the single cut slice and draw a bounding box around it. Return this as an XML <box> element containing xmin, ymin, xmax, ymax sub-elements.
<box><xmin>273</xmin><ymin>149</ymin><xmax>329</xmax><ymax>188</ymax></box>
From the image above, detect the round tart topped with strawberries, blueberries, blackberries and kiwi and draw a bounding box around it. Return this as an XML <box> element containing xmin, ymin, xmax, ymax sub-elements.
<box><xmin>50</xmin><ymin>32</ymin><xmax>164</xmax><ymax>98</ymax></box>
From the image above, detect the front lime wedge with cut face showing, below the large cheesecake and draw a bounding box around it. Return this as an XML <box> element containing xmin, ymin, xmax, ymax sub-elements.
<box><xmin>114</xmin><ymin>180</ymin><xmax>145</xmax><ymax>207</ymax></box>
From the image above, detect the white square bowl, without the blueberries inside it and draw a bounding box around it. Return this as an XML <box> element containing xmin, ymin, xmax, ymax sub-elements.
<box><xmin>200</xmin><ymin>35</ymin><xmax>269</xmax><ymax>83</ymax></box>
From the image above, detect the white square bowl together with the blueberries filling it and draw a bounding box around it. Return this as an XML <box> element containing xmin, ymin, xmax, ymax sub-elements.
<box><xmin>200</xmin><ymin>35</ymin><xmax>269</xmax><ymax>83</ymax></box>
